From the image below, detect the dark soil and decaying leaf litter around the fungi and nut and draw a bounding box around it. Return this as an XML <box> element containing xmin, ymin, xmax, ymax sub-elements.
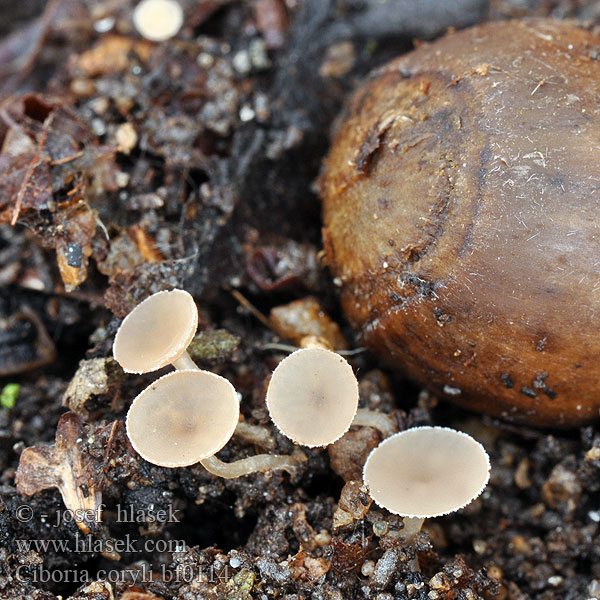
<box><xmin>0</xmin><ymin>0</ymin><xmax>600</xmax><ymax>600</ymax></box>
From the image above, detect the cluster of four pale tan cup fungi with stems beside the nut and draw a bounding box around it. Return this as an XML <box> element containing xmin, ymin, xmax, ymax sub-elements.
<box><xmin>113</xmin><ymin>289</ymin><xmax>490</xmax><ymax>539</ymax></box>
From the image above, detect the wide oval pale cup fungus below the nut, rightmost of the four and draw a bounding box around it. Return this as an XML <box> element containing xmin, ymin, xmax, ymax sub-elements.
<box><xmin>363</xmin><ymin>427</ymin><xmax>490</xmax><ymax>540</ymax></box>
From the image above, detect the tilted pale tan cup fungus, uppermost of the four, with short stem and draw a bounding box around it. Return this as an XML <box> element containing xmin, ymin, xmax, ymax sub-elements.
<box><xmin>113</xmin><ymin>289</ymin><xmax>198</xmax><ymax>373</ymax></box>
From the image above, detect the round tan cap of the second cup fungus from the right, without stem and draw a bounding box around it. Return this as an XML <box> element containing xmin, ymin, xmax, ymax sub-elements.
<box><xmin>267</xmin><ymin>348</ymin><xmax>358</xmax><ymax>448</ymax></box>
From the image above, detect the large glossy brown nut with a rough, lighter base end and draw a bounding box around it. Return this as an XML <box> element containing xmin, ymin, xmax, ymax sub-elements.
<box><xmin>320</xmin><ymin>20</ymin><xmax>600</xmax><ymax>427</ymax></box>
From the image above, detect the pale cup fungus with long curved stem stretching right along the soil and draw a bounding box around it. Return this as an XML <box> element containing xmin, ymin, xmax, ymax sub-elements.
<box><xmin>126</xmin><ymin>370</ymin><xmax>302</xmax><ymax>479</ymax></box>
